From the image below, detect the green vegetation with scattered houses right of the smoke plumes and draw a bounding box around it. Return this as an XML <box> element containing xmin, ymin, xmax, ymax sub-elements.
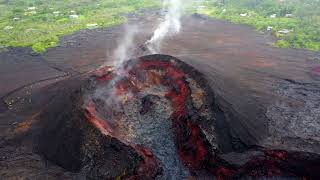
<box><xmin>197</xmin><ymin>0</ymin><xmax>320</xmax><ymax>51</ymax></box>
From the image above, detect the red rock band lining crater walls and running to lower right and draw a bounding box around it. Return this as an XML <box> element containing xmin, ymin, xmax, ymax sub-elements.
<box><xmin>82</xmin><ymin>56</ymin><xmax>320</xmax><ymax>179</ymax></box>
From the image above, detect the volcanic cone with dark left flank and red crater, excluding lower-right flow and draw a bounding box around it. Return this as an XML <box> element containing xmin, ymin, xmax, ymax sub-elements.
<box><xmin>39</xmin><ymin>55</ymin><xmax>217</xmax><ymax>179</ymax></box>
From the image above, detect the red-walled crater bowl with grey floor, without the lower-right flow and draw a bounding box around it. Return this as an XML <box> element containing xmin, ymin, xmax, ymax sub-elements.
<box><xmin>85</xmin><ymin>55</ymin><xmax>216</xmax><ymax>179</ymax></box>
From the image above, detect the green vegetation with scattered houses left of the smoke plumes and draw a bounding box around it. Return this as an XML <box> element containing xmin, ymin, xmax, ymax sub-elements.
<box><xmin>0</xmin><ymin>0</ymin><xmax>160</xmax><ymax>52</ymax></box>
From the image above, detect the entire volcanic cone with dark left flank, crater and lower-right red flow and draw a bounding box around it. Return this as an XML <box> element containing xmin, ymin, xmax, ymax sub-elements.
<box><xmin>37</xmin><ymin>55</ymin><xmax>320</xmax><ymax>179</ymax></box>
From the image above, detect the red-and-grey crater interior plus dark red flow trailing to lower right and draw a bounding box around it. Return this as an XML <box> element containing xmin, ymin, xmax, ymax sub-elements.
<box><xmin>85</xmin><ymin>55</ymin><xmax>319</xmax><ymax>179</ymax></box>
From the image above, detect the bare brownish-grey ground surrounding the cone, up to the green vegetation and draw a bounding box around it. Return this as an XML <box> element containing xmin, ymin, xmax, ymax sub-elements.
<box><xmin>0</xmin><ymin>12</ymin><xmax>320</xmax><ymax>178</ymax></box>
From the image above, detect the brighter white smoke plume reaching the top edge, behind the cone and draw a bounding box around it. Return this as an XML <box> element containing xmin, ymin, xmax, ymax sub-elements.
<box><xmin>146</xmin><ymin>0</ymin><xmax>182</xmax><ymax>53</ymax></box>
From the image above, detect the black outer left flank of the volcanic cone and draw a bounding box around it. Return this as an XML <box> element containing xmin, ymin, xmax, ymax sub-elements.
<box><xmin>37</xmin><ymin>80</ymin><xmax>152</xmax><ymax>179</ymax></box>
